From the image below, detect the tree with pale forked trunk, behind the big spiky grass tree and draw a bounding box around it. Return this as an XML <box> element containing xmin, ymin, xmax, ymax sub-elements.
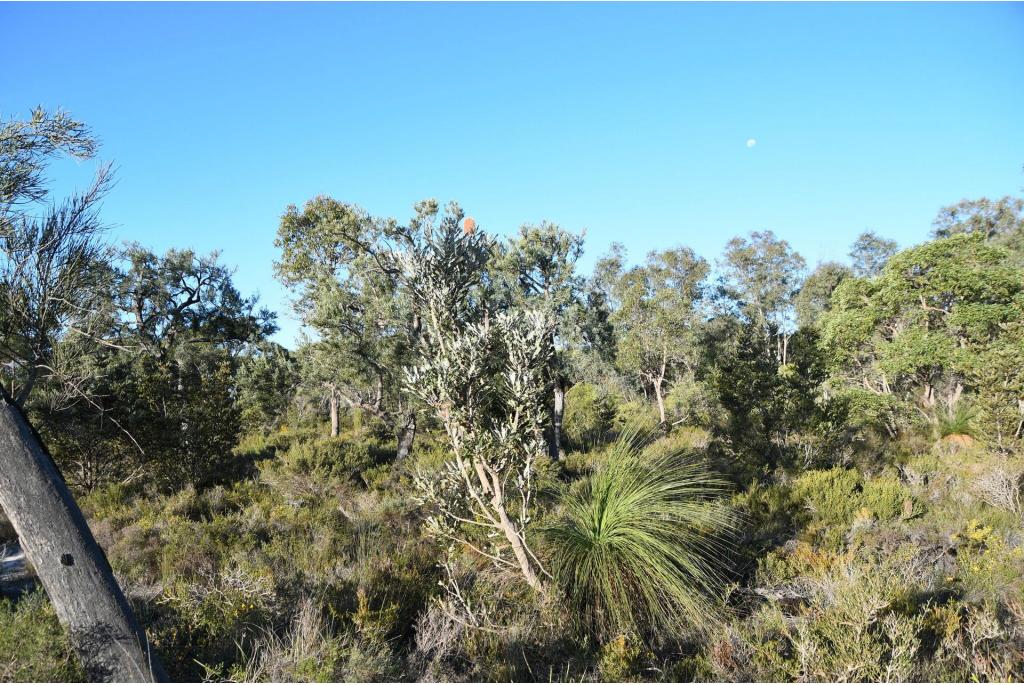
<box><xmin>597</xmin><ymin>242</ymin><xmax>710</xmax><ymax>423</ymax></box>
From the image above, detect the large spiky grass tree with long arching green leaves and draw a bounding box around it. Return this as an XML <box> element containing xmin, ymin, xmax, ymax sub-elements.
<box><xmin>545</xmin><ymin>436</ymin><xmax>732</xmax><ymax>635</ymax></box>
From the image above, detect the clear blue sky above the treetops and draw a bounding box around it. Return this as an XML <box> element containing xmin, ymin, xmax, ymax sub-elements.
<box><xmin>0</xmin><ymin>3</ymin><xmax>1024</xmax><ymax>344</ymax></box>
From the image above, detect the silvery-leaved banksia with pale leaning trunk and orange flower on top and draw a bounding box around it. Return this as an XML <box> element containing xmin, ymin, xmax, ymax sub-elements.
<box><xmin>398</xmin><ymin>209</ymin><xmax>553</xmax><ymax>591</ymax></box>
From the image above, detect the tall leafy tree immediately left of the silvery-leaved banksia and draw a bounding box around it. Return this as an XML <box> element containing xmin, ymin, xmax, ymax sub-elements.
<box><xmin>274</xmin><ymin>197</ymin><xmax>423</xmax><ymax>450</ymax></box>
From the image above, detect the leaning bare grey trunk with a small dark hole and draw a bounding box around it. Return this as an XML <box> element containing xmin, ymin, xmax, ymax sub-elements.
<box><xmin>0</xmin><ymin>392</ymin><xmax>166</xmax><ymax>682</ymax></box>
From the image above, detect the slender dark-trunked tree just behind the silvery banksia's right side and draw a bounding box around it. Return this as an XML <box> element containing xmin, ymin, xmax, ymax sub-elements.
<box><xmin>495</xmin><ymin>222</ymin><xmax>584</xmax><ymax>459</ymax></box>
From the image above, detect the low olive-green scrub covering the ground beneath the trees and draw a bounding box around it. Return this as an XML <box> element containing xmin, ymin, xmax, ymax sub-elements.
<box><xmin>8</xmin><ymin>411</ymin><xmax>1024</xmax><ymax>681</ymax></box>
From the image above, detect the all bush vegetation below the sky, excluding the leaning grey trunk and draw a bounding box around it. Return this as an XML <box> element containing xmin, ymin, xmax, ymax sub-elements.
<box><xmin>0</xmin><ymin>106</ymin><xmax>1024</xmax><ymax>682</ymax></box>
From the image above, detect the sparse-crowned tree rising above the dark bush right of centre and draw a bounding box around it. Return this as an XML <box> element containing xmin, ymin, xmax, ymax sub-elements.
<box><xmin>720</xmin><ymin>230</ymin><xmax>805</xmax><ymax>366</ymax></box>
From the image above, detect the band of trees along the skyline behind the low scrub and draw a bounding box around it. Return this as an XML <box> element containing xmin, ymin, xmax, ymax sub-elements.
<box><xmin>0</xmin><ymin>106</ymin><xmax>1024</xmax><ymax>488</ymax></box>
